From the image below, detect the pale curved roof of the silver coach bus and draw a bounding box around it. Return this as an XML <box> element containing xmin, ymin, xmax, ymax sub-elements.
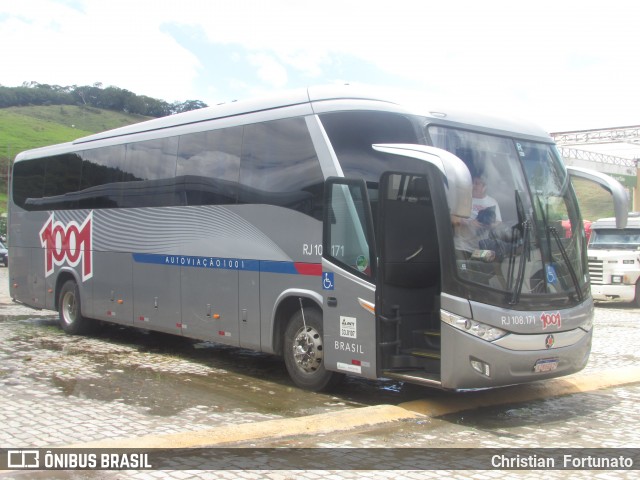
<box><xmin>16</xmin><ymin>85</ymin><xmax>553</xmax><ymax>161</ymax></box>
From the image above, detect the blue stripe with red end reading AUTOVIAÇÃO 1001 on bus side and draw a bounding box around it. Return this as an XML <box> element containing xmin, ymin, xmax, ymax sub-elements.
<box><xmin>132</xmin><ymin>253</ymin><xmax>322</xmax><ymax>276</ymax></box>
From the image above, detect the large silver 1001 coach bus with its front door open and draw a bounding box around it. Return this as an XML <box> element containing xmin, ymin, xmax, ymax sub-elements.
<box><xmin>9</xmin><ymin>87</ymin><xmax>627</xmax><ymax>390</ymax></box>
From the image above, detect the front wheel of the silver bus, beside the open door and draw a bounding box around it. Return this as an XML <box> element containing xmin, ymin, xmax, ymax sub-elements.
<box><xmin>284</xmin><ymin>308</ymin><xmax>344</xmax><ymax>392</ymax></box>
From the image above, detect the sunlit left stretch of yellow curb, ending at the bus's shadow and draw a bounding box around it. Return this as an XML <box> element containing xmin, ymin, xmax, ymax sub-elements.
<box><xmin>65</xmin><ymin>405</ymin><xmax>422</xmax><ymax>449</ymax></box>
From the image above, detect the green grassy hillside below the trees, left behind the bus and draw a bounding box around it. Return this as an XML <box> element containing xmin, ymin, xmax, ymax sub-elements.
<box><xmin>0</xmin><ymin>105</ymin><xmax>149</xmax><ymax>213</ymax></box>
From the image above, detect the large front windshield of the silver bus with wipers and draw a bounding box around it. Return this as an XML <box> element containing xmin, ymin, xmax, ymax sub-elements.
<box><xmin>428</xmin><ymin>125</ymin><xmax>587</xmax><ymax>305</ymax></box>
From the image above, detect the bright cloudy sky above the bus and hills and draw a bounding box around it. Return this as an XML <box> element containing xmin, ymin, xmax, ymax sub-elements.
<box><xmin>0</xmin><ymin>0</ymin><xmax>640</xmax><ymax>132</ymax></box>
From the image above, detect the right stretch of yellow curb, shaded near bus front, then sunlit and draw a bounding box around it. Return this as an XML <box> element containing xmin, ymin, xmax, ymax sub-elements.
<box><xmin>399</xmin><ymin>367</ymin><xmax>640</xmax><ymax>417</ymax></box>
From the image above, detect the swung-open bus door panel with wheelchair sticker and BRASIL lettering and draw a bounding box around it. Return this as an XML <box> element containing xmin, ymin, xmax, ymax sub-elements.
<box><xmin>322</xmin><ymin>178</ymin><xmax>378</xmax><ymax>378</ymax></box>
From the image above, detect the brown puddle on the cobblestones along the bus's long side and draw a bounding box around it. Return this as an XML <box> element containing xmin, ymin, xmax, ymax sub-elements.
<box><xmin>3</xmin><ymin>318</ymin><xmax>426</xmax><ymax>416</ymax></box>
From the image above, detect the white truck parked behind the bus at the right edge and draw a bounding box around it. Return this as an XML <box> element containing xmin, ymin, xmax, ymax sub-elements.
<box><xmin>588</xmin><ymin>212</ymin><xmax>640</xmax><ymax>307</ymax></box>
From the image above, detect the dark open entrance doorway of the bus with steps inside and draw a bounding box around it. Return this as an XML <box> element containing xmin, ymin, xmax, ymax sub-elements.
<box><xmin>376</xmin><ymin>172</ymin><xmax>441</xmax><ymax>383</ymax></box>
